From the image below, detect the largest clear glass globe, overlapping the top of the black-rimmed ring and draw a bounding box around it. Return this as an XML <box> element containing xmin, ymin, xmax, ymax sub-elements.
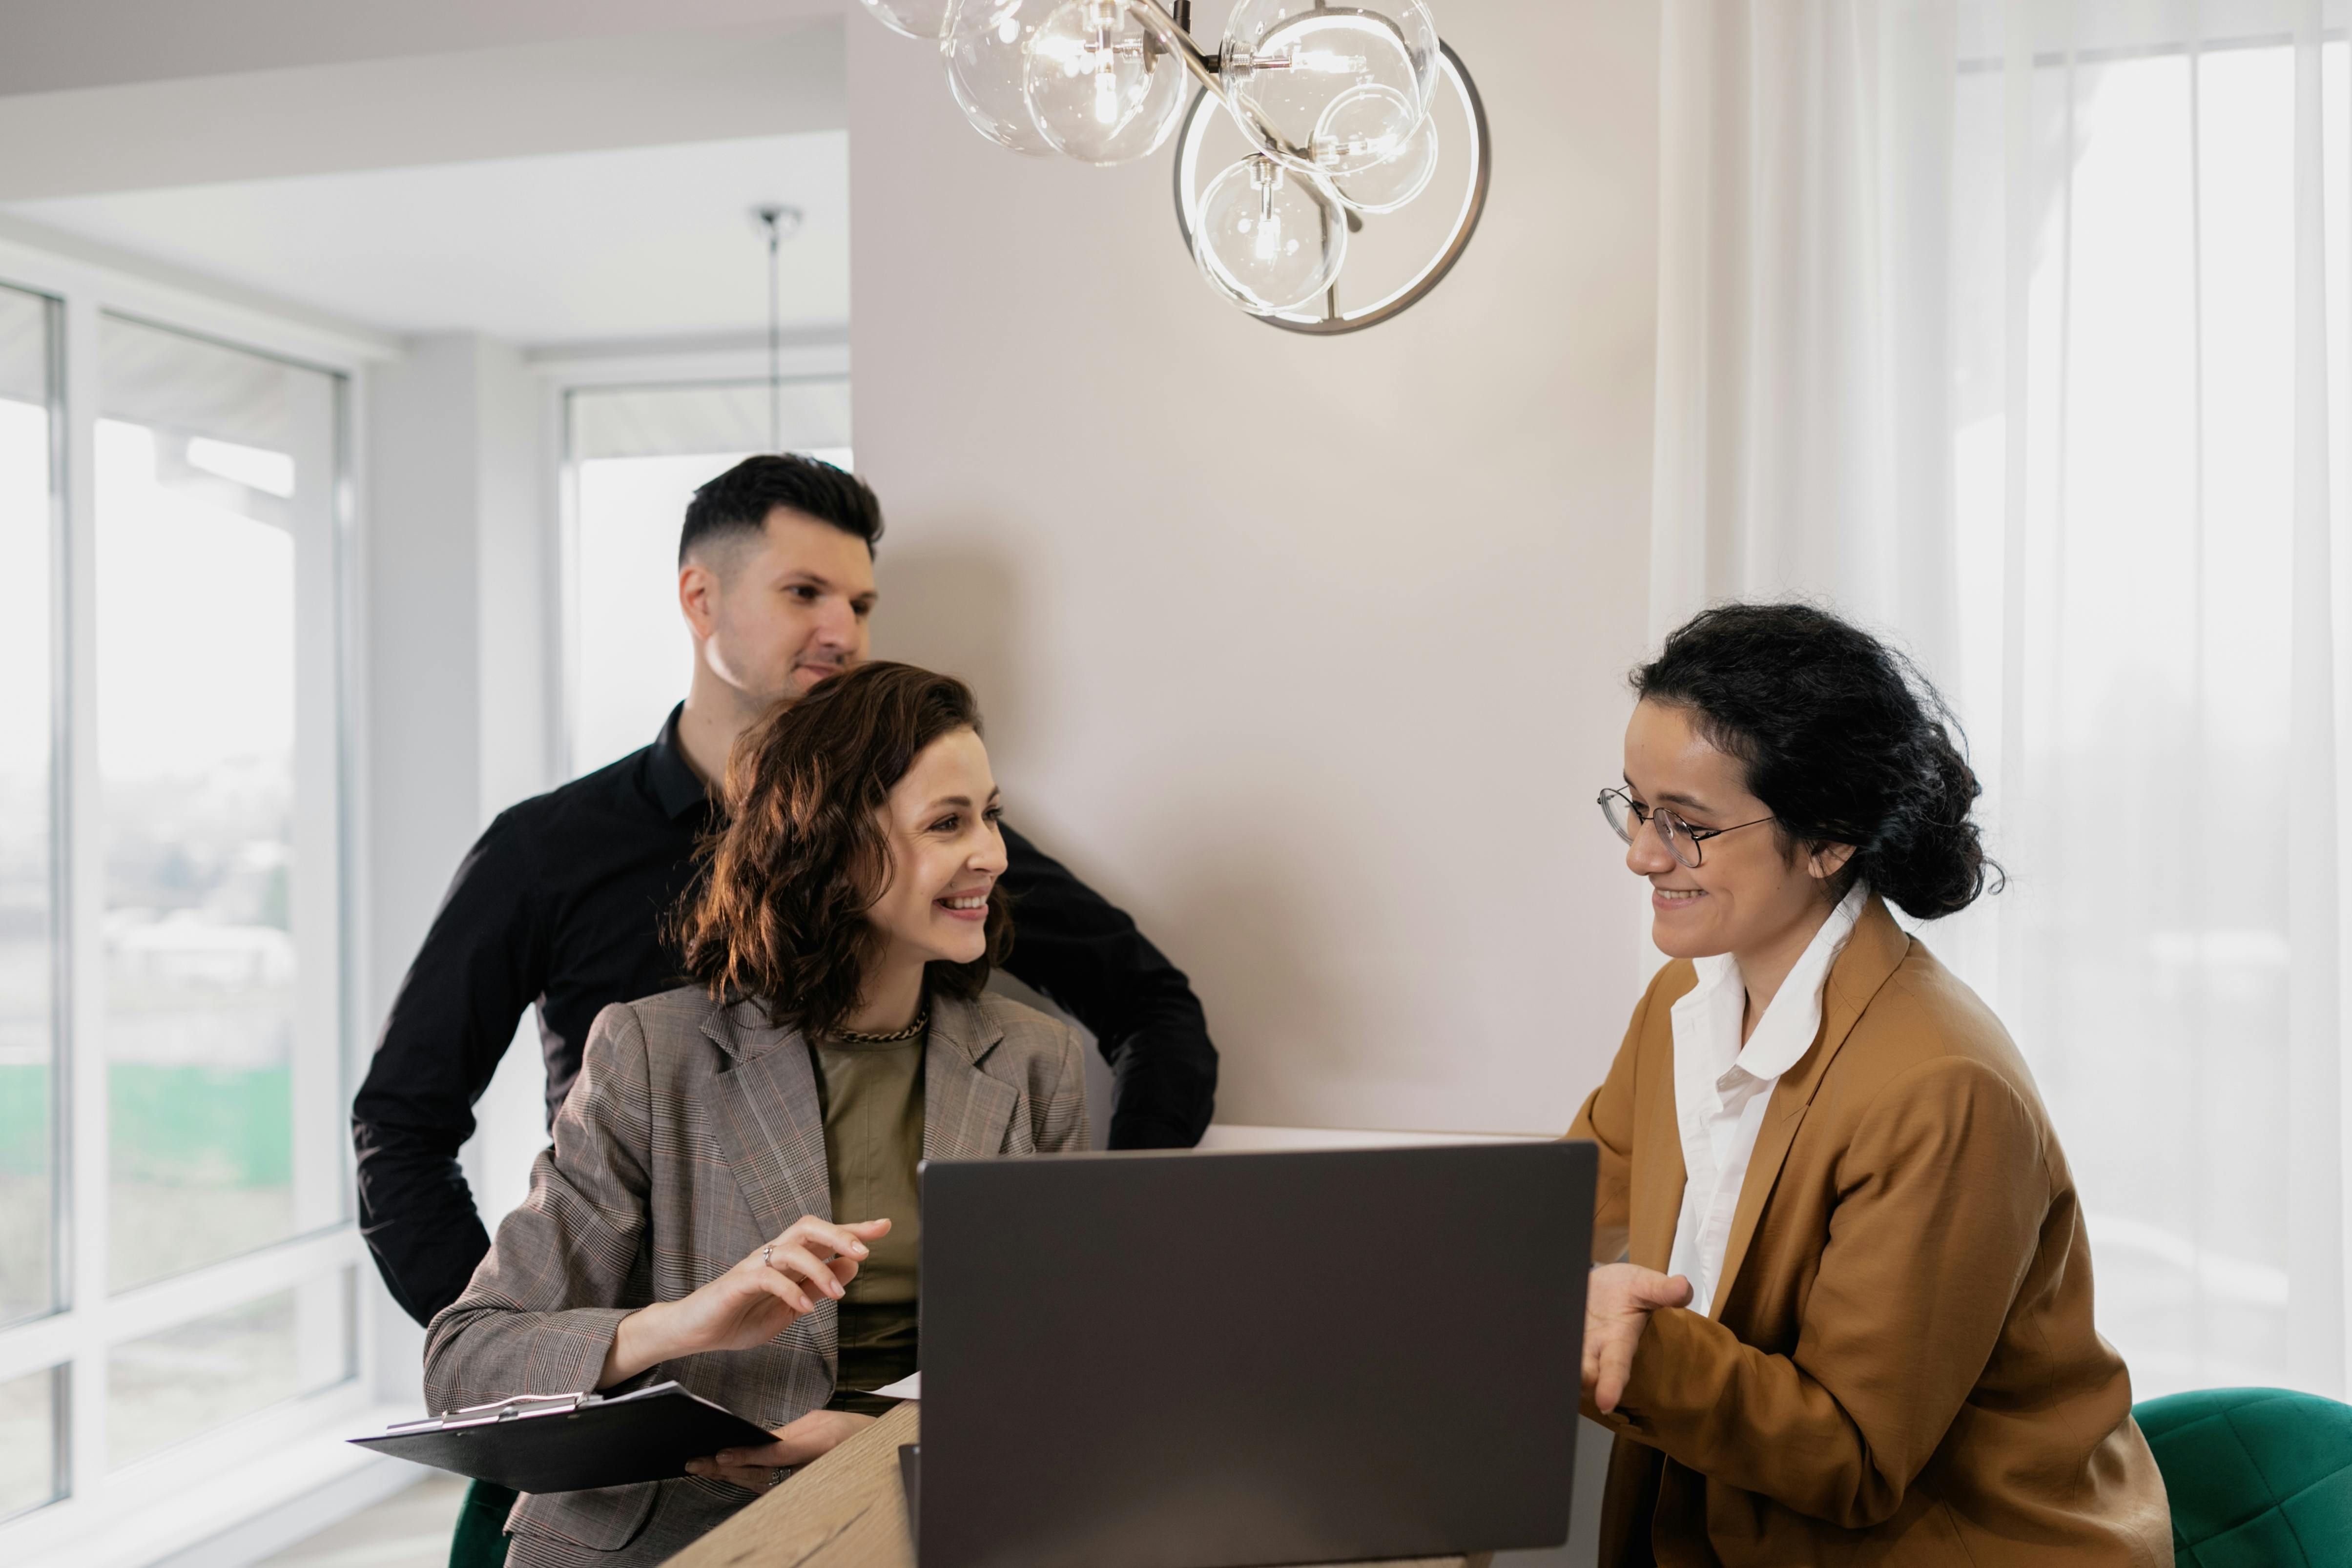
<box><xmin>1221</xmin><ymin>0</ymin><xmax>1440</xmax><ymax>176</ymax></box>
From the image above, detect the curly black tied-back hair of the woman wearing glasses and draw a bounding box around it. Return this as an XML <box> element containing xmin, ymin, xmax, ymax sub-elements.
<box><xmin>1632</xmin><ymin>604</ymin><xmax>2001</xmax><ymax>919</ymax></box>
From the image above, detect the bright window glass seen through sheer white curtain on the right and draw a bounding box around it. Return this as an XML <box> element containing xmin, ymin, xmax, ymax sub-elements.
<box><xmin>1926</xmin><ymin>38</ymin><xmax>2352</xmax><ymax>1396</ymax></box>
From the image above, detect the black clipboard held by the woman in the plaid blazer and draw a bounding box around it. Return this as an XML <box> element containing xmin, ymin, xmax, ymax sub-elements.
<box><xmin>351</xmin><ymin>1382</ymin><xmax>776</xmax><ymax>1493</ymax></box>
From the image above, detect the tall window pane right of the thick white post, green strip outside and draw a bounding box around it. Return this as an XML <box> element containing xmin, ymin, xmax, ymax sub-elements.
<box><xmin>97</xmin><ymin>317</ymin><xmax>343</xmax><ymax>1291</ymax></box>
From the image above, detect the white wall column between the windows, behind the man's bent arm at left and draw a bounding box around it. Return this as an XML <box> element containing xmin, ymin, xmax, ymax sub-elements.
<box><xmin>362</xmin><ymin>334</ymin><xmax>555</xmax><ymax>1399</ymax></box>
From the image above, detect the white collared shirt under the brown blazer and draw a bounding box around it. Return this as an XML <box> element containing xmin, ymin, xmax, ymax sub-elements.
<box><xmin>1665</xmin><ymin>882</ymin><xmax>1870</xmax><ymax>1317</ymax></box>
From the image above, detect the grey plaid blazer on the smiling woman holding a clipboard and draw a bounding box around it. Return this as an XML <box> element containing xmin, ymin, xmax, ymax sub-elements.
<box><xmin>426</xmin><ymin>988</ymin><xmax>1087</xmax><ymax>1568</ymax></box>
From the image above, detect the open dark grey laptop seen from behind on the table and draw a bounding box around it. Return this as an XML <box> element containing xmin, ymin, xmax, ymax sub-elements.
<box><xmin>908</xmin><ymin>1142</ymin><xmax>1595</xmax><ymax>1568</ymax></box>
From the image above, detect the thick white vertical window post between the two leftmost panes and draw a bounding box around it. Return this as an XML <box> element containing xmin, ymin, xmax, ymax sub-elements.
<box><xmin>59</xmin><ymin>294</ymin><xmax>108</xmax><ymax>1523</ymax></box>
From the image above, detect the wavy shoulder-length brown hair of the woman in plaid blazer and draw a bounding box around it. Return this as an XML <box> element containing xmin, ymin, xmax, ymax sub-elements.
<box><xmin>678</xmin><ymin>660</ymin><xmax>1014</xmax><ymax>1034</ymax></box>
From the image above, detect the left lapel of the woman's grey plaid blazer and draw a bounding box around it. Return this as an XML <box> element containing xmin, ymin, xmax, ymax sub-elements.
<box><xmin>703</xmin><ymin>1001</ymin><xmax>833</xmax><ymax>1237</ymax></box>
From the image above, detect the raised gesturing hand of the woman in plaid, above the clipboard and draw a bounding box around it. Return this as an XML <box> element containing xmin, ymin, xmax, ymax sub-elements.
<box><xmin>595</xmin><ymin>1216</ymin><xmax>889</xmax><ymax>1389</ymax></box>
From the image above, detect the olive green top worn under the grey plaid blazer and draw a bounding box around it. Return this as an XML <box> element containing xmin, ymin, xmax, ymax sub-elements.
<box><xmin>809</xmin><ymin>1037</ymin><xmax>927</xmax><ymax>1413</ymax></box>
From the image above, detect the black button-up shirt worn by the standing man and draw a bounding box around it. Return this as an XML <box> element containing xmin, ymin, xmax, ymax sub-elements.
<box><xmin>353</xmin><ymin>712</ymin><xmax>1216</xmax><ymax>1323</ymax></box>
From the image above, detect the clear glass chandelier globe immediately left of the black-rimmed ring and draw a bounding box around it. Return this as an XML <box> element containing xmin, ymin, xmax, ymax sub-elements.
<box><xmin>1021</xmin><ymin>0</ymin><xmax>1193</xmax><ymax>165</ymax></box>
